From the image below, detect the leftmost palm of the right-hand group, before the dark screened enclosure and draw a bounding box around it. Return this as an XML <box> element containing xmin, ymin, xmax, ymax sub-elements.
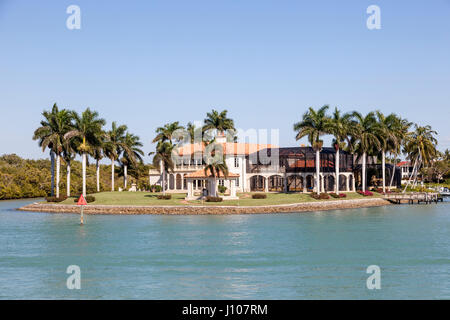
<box><xmin>294</xmin><ymin>105</ymin><xmax>329</xmax><ymax>194</ymax></box>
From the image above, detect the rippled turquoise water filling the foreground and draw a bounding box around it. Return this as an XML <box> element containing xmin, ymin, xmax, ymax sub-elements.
<box><xmin>0</xmin><ymin>201</ymin><xmax>450</xmax><ymax>299</ymax></box>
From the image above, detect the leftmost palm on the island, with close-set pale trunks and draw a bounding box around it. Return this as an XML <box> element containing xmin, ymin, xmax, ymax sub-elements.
<box><xmin>33</xmin><ymin>103</ymin><xmax>71</xmax><ymax>198</ymax></box>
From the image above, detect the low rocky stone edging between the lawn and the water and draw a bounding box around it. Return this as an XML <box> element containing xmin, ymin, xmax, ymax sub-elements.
<box><xmin>18</xmin><ymin>198</ymin><xmax>391</xmax><ymax>215</ymax></box>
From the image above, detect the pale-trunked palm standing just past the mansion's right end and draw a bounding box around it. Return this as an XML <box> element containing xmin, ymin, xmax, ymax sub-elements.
<box><xmin>351</xmin><ymin>111</ymin><xmax>381</xmax><ymax>191</ymax></box>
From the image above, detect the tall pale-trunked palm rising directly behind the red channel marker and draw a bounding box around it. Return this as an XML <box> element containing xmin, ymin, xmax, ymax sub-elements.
<box><xmin>65</xmin><ymin>108</ymin><xmax>105</xmax><ymax>197</ymax></box>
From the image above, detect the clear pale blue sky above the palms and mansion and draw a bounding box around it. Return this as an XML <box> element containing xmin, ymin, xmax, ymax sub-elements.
<box><xmin>0</xmin><ymin>0</ymin><xmax>450</xmax><ymax>161</ymax></box>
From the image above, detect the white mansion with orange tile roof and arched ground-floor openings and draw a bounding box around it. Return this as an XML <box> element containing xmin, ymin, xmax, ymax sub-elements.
<box><xmin>149</xmin><ymin>137</ymin><xmax>355</xmax><ymax>198</ymax></box>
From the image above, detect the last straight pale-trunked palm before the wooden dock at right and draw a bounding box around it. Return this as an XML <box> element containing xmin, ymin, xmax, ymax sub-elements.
<box><xmin>376</xmin><ymin>110</ymin><xmax>400</xmax><ymax>193</ymax></box>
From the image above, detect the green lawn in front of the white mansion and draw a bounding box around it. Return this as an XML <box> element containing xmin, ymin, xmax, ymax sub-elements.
<box><xmin>55</xmin><ymin>192</ymin><xmax>380</xmax><ymax>206</ymax></box>
